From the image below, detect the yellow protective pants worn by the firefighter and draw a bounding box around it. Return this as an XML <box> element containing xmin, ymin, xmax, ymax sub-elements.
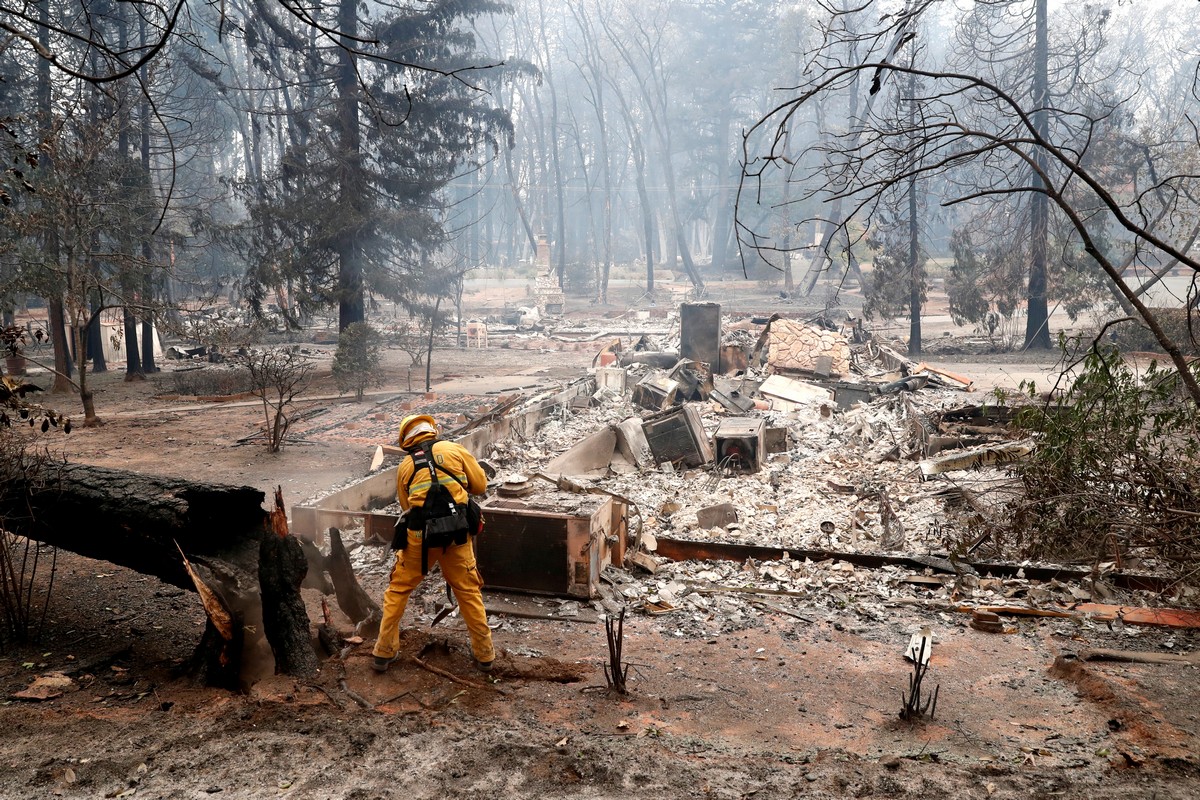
<box><xmin>373</xmin><ymin>530</ymin><xmax>496</xmax><ymax>663</ymax></box>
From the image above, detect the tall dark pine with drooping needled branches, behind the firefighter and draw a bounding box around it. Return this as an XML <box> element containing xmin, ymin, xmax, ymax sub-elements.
<box><xmin>246</xmin><ymin>0</ymin><xmax>512</xmax><ymax>330</ymax></box>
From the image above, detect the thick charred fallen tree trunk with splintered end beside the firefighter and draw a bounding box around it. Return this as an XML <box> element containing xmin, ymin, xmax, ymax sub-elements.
<box><xmin>0</xmin><ymin>464</ymin><xmax>316</xmax><ymax>687</ymax></box>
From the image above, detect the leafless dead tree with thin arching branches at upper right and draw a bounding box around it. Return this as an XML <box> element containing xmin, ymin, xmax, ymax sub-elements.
<box><xmin>739</xmin><ymin>1</ymin><xmax>1200</xmax><ymax>404</ymax></box>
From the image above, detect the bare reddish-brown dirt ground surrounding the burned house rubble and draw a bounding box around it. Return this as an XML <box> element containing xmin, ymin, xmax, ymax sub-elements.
<box><xmin>0</xmin><ymin>289</ymin><xmax>1200</xmax><ymax>800</ymax></box>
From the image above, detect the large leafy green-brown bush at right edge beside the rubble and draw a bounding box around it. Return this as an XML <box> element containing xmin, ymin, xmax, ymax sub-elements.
<box><xmin>1003</xmin><ymin>340</ymin><xmax>1200</xmax><ymax>583</ymax></box>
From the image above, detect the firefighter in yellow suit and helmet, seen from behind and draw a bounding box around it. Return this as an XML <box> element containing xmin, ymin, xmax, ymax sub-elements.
<box><xmin>372</xmin><ymin>414</ymin><xmax>496</xmax><ymax>672</ymax></box>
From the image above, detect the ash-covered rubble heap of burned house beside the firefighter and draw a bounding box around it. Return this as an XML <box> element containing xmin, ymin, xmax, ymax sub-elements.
<box><xmin>298</xmin><ymin>303</ymin><xmax>1190</xmax><ymax>637</ymax></box>
